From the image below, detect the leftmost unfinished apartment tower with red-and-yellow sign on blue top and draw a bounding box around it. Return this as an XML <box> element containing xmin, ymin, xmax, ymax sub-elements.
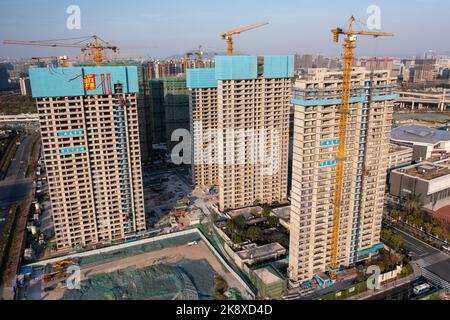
<box><xmin>30</xmin><ymin>66</ymin><xmax>145</xmax><ymax>249</ymax></box>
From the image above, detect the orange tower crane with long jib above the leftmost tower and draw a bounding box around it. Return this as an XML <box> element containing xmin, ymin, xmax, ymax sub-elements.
<box><xmin>3</xmin><ymin>35</ymin><xmax>119</xmax><ymax>67</ymax></box>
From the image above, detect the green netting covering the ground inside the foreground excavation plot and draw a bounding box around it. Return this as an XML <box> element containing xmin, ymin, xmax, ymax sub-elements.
<box><xmin>63</xmin><ymin>259</ymin><xmax>215</xmax><ymax>300</ymax></box>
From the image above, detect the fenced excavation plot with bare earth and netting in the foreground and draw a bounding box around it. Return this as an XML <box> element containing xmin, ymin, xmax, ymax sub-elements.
<box><xmin>17</xmin><ymin>229</ymin><xmax>252</xmax><ymax>300</ymax></box>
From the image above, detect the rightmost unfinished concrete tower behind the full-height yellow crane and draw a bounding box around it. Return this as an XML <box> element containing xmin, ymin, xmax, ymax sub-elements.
<box><xmin>289</xmin><ymin>68</ymin><xmax>396</xmax><ymax>283</ymax></box>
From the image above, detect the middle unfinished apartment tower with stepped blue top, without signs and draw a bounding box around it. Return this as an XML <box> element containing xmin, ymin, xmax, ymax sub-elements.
<box><xmin>187</xmin><ymin>56</ymin><xmax>294</xmax><ymax>211</ymax></box>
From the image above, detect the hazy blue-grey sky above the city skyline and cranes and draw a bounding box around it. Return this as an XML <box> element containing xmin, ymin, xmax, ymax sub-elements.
<box><xmin>0</xmin><ymin>0</ymin><xmax>450</xmax><ymax>57</ymax></box>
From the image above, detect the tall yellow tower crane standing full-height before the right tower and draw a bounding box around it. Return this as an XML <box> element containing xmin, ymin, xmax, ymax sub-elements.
<box><xmin>329</xmin><ymin>16</ymin><xmax>393</xmax><ymax>280</ymax></box>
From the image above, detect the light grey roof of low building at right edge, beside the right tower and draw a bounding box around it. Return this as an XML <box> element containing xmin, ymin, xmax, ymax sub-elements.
<box><xmin>391</xmin><ymin>125</ymin><xmax>450</xmax><ymax>145</ymax></box>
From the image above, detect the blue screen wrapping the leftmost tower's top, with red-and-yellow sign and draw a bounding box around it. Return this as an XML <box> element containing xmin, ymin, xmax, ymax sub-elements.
<box><xmin>29</xmin><ymin>66</ymin><xmax>139</xmax><ymax>98</ymax></box>
